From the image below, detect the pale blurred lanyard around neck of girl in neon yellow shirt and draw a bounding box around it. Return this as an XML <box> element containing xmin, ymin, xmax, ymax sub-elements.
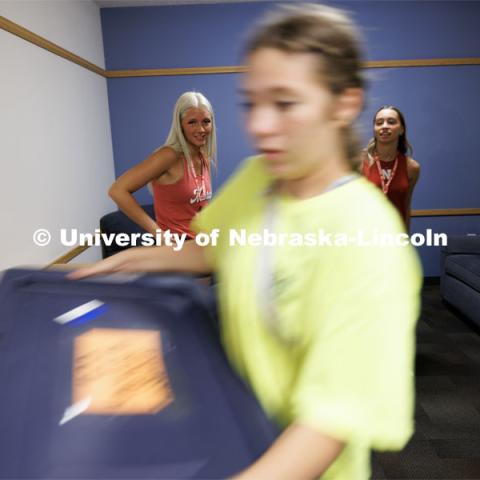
<box><xmin>256</xmin><ymin>173</ymin><xmax>358</xmax><ymax>344</ymax></box>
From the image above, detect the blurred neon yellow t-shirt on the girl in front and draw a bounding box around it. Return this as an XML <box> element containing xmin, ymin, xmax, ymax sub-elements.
<box><xmin>193</xmin><ymin>157</ymin><xmax>421</xmax><ymax>480</ymax></box>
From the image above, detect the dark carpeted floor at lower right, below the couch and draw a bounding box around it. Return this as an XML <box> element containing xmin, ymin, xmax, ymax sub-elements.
<box><xmin>373</xmin><ymin>285</ymin><xmax>480</xmax><ymax>480</ymax></box>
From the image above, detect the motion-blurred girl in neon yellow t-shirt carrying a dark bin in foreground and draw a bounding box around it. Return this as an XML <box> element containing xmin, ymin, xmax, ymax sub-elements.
<box><xmin>74</xmin><ymin>5</ymin><xmax>420</xmax><ymax>480</ymax></box>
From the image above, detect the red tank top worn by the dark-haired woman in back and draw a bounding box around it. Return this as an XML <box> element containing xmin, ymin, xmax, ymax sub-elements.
<box><xmin>362</xmin><ymin>152</ymin><xmax>409</xmax><ymax>225</ymax></box>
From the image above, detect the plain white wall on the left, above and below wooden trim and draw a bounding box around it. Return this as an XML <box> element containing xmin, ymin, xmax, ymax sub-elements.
<box><xmin>0</xmin><ymin>0</ymin><xmax>114</xmax><ymax>270</ymax></box>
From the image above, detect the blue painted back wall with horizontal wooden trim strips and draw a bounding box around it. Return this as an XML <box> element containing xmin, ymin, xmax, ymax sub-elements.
<box><xmin>101</xmin><ymin>1</ymin><xmax>480</xmax><ymax>276</ymax></box>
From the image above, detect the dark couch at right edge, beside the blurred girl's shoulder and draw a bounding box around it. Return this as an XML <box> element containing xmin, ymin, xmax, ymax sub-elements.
<box><xmin>440</xmin><ymin>235</ymin><xmax>480</xmax><ymax>327</ymax></box>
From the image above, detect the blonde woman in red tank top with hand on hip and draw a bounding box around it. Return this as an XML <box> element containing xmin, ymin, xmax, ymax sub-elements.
<box><xmin>108</xmin><ymin>92</ymin><xmax>216</xmax><ymax>238</ymax></box>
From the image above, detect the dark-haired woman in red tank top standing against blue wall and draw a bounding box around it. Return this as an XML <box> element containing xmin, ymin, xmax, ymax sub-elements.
<box><xmin>362</xmin><ymin>106</ymin><xmax>420</xmax><ymax>231</ymax></box>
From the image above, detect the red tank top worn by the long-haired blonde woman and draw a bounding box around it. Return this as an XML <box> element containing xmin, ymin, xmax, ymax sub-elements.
<box><xmin>152</xmin><ymin>155</ymin><xmax>212</xmax><ymax>238</ymax></box>
